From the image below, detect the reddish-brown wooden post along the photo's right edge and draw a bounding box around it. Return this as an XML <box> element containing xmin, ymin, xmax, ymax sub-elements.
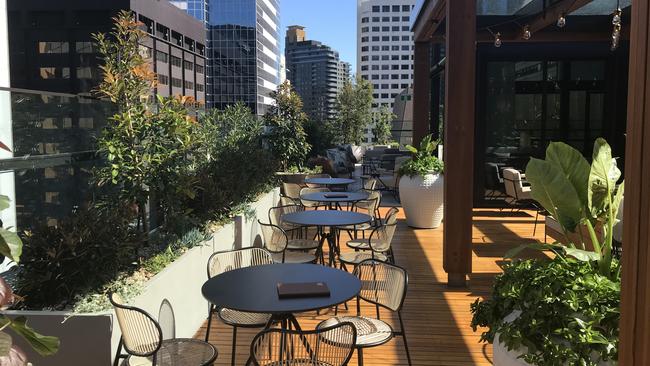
<box><xmin>619</xmin><ymin>0</ymin><xmax>650</xmax><ymax>366</ymax></box>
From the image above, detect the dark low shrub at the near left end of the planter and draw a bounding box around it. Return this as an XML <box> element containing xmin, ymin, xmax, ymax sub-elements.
<box><xmin>18</xmin><ymin>207</ymin><xmax>143</xmax><ymax>309</ymax></box>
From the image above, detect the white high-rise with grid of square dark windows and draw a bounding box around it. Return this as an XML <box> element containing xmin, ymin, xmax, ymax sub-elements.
<box><xmin>357</xmin><ymin>0</ymin><xmax>416</xmax><ymax>139</ymax></box>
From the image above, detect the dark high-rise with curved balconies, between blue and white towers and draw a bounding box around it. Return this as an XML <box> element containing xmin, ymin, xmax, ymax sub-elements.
<box><xmin>284</xmin><ymin>25</ymin><xmax>350</xmax><ymax>121</ymax></box>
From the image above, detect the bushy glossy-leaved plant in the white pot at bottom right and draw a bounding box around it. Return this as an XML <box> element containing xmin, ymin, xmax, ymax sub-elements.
<box><xmin>471</xmin><ymin>256</ymin><xmax>620</xmax><ymax>366</ymax></box>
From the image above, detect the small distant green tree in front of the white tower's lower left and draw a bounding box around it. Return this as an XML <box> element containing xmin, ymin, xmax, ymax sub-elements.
<box><xmin>332</xmin><ymin>77</ymin><xmax>373</xmax><ymax>145</ymax></box>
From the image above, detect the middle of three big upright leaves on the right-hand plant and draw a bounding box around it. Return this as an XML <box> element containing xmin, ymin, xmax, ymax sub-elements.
<box><xmin>546</xmin><ymin>142</ymin><xmax>590</xmax><ymax>210</ymax></box>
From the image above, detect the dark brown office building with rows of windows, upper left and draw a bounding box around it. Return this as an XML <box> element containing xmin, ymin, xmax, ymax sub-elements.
<box><xmin>8</xmin><ymin>0</ymin><xmax>205</xmax><ymax>101</ymax></box>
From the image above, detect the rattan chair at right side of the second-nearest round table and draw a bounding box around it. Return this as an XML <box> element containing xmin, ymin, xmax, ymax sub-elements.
<box><xmin>339</xmin><ymin>208</ymin><xmax>398</xmax><ymax>268</ymax></box>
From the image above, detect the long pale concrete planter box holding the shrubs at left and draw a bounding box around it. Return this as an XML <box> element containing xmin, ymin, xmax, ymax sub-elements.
<box><xmin>6</xmin><ymin>189</ymin><xmax>279</xmax><ymax>366</ymax></box>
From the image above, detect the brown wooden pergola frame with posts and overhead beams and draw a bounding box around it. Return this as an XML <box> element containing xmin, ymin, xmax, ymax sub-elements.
<box><xmin>413</xmin><ymin>0</ymin><xmax>650</xmax><ymax>366</ymax></box>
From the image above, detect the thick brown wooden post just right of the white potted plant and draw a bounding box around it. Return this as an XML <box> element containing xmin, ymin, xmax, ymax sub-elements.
<box><xmin>443</xmin><ymin>0</ymin><xmax>476</xmax><ymax>286</ymax></box>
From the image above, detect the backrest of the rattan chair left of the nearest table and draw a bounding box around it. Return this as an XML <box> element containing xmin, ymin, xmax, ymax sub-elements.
<box><xmin>108</xmin><ymin>293</ymin><xmax>162</xmax><ymax>357</ymax></box>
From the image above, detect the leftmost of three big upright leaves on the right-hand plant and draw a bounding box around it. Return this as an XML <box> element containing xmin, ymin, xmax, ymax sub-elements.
<box><xmin>526</xmin><ymin>158</ymin><xmax>583</xmax><ymax>232</ymax></box>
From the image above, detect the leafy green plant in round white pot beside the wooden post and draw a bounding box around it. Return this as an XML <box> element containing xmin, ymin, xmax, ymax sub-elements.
<box><xmin>398</xmin><ymin>135</ymin><xmax>444</xmax><ymax>229</ymax></box>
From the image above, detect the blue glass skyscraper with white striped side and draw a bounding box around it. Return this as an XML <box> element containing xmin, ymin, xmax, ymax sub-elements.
<box><xmin>173</xmin><ymin>0</ymin><xmax>280</xmax><ymax>115</ymax></box>
